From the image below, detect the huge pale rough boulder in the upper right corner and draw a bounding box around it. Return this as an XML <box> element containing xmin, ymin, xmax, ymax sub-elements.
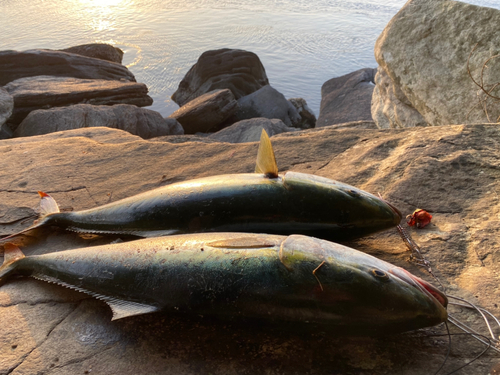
<box><xmin>375</xmin><ymin>0</ymin><xmax>500</xmax><ymax>127</ymax></box>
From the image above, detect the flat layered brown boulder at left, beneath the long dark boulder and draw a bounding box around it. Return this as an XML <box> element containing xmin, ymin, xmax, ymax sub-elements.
<box><xmin>4</xmin><ymin>76</ymin><xmax>153</xmax><ymax>130</ymax></box>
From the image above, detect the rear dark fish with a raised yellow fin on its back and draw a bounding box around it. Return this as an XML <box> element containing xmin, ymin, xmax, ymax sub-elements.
<box><xmin>1</xmin><ymin>130</ymin><xmax>402</xmax><ymax>243</ymax></box>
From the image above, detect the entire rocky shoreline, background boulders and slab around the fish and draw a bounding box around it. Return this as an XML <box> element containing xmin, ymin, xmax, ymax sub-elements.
<box><xmin>0</xmin><ymin>0</ymin><xmax>500</xmax><ymax>375</ymax></box>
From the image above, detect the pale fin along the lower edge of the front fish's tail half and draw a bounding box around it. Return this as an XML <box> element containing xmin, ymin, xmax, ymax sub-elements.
<box><xmin>31</xmin><ymin>273</ymin><xmax>159</xmax><ymax>320</ymax></box>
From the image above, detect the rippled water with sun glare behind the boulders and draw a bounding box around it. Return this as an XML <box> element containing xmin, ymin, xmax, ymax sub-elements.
<box><xmin>0</xmin><ymin>0</ymin><xmax>500</xmax><ymax>117</ymax></box>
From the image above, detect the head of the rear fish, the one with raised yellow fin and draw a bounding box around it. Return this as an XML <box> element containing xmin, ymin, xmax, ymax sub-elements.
<box><xmin>283</xmin><ymin>171</ymin><xmax>403</xmax><ymax>238</ymax></box>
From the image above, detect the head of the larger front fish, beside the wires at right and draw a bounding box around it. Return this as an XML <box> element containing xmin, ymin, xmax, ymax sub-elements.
<box><xmin>280</xmin><ymin>235</ymin><xmax>448</xmax><ymax>333</ymax></box>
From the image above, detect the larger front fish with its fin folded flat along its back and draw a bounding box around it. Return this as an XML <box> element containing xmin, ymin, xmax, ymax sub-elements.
<box><xmin>0</xmin><ymin>232</ymin><xmax>448</xmax><ymax>334</ymax></box>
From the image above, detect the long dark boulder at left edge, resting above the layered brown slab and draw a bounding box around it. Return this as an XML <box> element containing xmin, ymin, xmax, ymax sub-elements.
<box><xmin>0</xmin><ymin>49</ymin><xmax>135</xmax><ymax>86</ymax></box>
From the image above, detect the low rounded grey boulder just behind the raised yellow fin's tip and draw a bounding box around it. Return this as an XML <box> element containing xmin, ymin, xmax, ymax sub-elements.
<box><xmin>208</xmin><ymin>118</ymin><xmax>297</xmax><ymax>143</ymax></box>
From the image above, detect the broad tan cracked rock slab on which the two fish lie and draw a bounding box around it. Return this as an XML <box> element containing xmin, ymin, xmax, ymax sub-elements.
<box><xmin>0</xmin><ymin>125</ymin><xmax>500</xmax><ymax>375</ymax></box>
